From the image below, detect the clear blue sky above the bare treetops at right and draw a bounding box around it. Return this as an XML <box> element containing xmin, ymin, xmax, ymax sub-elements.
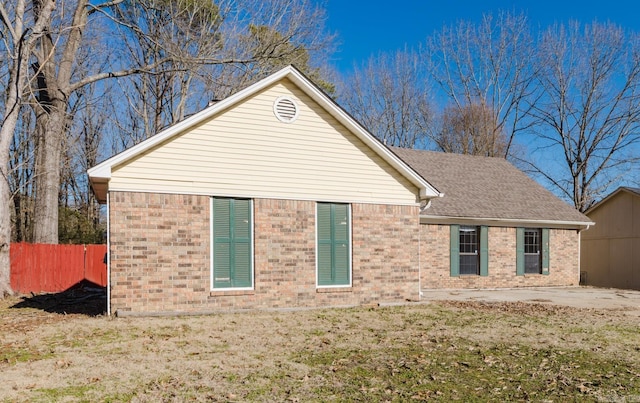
<box><xmin>319</xmin><ymin>0</ymin><xmax>640</xmax><ymax>72</ymax></box>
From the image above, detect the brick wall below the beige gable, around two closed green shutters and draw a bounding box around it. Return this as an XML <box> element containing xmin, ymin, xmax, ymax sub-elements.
<box><xmin>110</xmin><ymin>192</ymin><xmax>419</xmax><ymax>312</ymax></box>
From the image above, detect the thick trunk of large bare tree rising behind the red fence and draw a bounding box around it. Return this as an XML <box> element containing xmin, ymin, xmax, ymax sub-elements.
<box><xmin>26</xmin><ymin>0</ymin><xmax>120</xmax><ymax>243</ymax></box>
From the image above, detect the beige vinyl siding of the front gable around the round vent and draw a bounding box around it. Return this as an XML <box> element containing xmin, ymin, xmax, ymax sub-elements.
<box><xmin>109</xmin><ymin>80</ymin><xmax>418</xmax><ymax>204</ymax></box>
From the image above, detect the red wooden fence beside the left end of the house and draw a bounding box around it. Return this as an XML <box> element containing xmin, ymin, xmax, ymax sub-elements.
<box><xmin>11</xmin><ymin>243</ymin><xmax>107</xmax><ymax>293</ymax></box>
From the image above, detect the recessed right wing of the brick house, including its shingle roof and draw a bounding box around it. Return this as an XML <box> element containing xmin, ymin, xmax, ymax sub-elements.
<box><xmin>393</xmin><ymin>148</ymin><xmax>594</xmax><ymax>292</ymax></box>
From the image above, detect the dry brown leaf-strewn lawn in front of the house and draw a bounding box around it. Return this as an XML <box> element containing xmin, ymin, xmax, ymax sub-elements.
<box><xmin>0</xmin><ymin>297</ymin><xmax>640</xmax><ymax>402</ymax></box>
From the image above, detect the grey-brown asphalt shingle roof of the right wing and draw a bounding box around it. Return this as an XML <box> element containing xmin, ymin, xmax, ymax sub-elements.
<box><xmin>390</xmin><ymin>147</ymin><xmax>591</xmax><ymax>224</ymax></box>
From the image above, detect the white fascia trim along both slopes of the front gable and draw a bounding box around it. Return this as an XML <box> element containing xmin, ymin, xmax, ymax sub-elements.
<box><xmin>87</xmin><ymin>66</ymin><xmax>442</xmax><ymax>199</ymax></box>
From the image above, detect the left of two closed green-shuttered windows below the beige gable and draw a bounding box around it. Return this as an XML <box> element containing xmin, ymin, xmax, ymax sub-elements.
<box><xmin>211</xmin><ymin>197</ymin><xmax>253</xmax><ymax>289</ymax></box>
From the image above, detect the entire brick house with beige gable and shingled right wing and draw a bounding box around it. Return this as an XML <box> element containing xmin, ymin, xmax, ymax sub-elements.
<box><xmin>88</xmin><ymin>67</ymin><xmax>590</xmax><ymax>315</ymax></box>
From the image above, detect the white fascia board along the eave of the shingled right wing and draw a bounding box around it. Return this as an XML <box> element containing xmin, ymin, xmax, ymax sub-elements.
<box><xmin>420</xmin><ymin>214</ymin><xmax>596</xmax><ymax>229</ymax></box>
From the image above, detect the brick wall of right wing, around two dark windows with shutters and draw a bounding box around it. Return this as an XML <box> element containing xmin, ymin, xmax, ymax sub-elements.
<box><xmin>420</xmin><ymin>224</ymin><xmax>579</xmax><ymax>289</ymax></box>
